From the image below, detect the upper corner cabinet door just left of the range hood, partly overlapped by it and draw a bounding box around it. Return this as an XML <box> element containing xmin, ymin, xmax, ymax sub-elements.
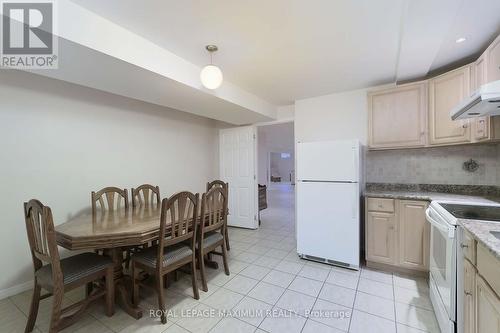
<box><xmin>429</xmin><ymin>66</ymin><xmax>470</xmax><ymax>145</ymax></box>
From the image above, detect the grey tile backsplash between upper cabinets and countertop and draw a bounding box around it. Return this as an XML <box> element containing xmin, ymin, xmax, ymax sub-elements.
<box><xmin>366</xmin><ymin>144</ymin><xmax>500</xmax><ymax>185</ymax></box>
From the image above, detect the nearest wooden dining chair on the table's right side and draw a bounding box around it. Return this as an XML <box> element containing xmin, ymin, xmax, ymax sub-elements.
<box><xmin>132</xmin><ymin>192</ymin><xmax>200</xmax><ymax>324</ymax></box>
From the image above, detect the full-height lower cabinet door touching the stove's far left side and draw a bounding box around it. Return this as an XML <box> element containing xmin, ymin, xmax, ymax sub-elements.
<box><xmin>399</xmin><ymin>200</ymin><xmax>430</xmax><ymax>270</ymax></box>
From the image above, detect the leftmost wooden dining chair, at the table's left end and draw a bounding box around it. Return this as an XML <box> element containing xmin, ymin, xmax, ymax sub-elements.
<box><xmin>24</xmin><ymin>199</ymin><xmax>114</xmax><ymax>333</ymax></box>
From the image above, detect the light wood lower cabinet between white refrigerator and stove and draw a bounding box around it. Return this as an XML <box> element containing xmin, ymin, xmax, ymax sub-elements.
<box><xmin>365</xmin><ymin>197</ymin><xmax>430</xmax><ymax>271</ymax></box>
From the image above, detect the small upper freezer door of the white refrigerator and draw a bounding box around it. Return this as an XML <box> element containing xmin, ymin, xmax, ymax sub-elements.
<box><xmin>297</xmin><ymin>140</ymin><xmax>360</xmax><ymax>182</ymax></box>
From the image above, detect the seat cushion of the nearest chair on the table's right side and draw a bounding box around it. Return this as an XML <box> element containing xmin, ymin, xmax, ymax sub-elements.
<box><xmin>132</xmin><ymin>243</ymin><xmax>193</xmax><ymax>267</ymax></box>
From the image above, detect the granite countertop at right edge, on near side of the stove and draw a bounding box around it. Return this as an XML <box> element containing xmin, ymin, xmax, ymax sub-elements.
<box><xmin>458</xmin><ymin>219</ymin><xmax>500</xmax><ymax>260</ymax></box>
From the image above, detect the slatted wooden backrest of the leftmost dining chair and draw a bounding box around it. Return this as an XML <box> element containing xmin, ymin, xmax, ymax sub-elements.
<box><xmin>24</xmin><ymin>199</ymin><xmax>62</xmax><ymax>283</ymax></box>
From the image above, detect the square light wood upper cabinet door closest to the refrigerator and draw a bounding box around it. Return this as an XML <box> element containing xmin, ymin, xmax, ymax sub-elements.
<box><xmin>368</xmin><ymin>83</ymin><xmax>427</xmax><ymax>148</ymax></box>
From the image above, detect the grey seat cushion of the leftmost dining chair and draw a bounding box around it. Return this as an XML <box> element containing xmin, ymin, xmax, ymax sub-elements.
<box><xmin>35</xmin><ymin>252</ymin><xmax>113</xmax><ymax>289</ymax></box>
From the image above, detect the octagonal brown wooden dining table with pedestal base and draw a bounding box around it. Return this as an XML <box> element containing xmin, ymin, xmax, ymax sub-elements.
<box><xmin>55</xmin><ymin>206</ymin><xmax>217</xmax><ymax>319</ymax></box>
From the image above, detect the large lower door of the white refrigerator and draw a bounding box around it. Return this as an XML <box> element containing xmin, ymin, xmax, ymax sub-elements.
<box><xmin>297</xmin><ymin>182</ymin><xmax>360</xmax><ymax>267</ymax></box>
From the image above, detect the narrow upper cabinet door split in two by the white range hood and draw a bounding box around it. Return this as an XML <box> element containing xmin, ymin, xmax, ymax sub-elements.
<box><xmin>471</xmin><ymin>52</ymin><xmax>490</xmax><ymax>141</ymax></box>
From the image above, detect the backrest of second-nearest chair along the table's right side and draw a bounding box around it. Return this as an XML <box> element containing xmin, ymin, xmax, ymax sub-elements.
<box><xmin>200</xmin><ymin>187</ymin><xmax>227</xmax><ymax>235</ymax></box>
